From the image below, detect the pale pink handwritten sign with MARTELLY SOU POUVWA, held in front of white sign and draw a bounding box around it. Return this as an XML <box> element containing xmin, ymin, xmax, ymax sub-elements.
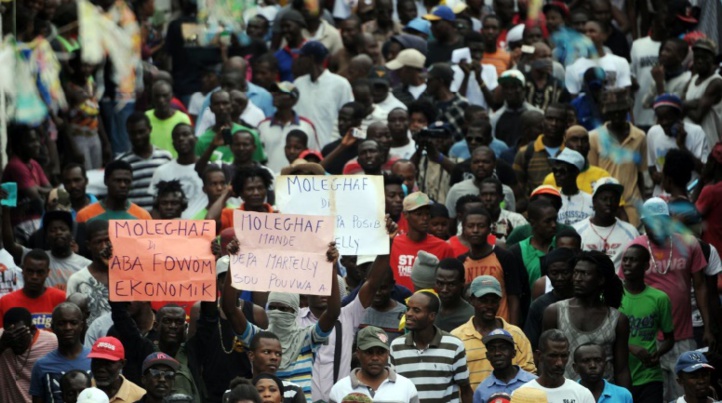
<box><xmin>231</xmin><ymin>210</ymin><xmax>335</xmax><ymax>295</ymax></box>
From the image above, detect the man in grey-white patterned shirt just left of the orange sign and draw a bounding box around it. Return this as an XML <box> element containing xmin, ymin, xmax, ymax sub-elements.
<box><xmin>66</xmin><ymin>220</ymin><xmax>110</xmax><ymax>326</ymax></box>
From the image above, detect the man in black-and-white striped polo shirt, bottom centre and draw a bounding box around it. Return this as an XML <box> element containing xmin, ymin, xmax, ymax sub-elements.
<box><xmin>391</xmin><ymin>291</ymin><xmax>473</xmax><ymax>403</ymax></box>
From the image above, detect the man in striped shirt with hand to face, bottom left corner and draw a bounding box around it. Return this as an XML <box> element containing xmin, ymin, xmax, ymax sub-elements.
<box><xmin>0</xmin><ymin>307</ymin><xmax>58</xmax><ymax>402</ymax></box>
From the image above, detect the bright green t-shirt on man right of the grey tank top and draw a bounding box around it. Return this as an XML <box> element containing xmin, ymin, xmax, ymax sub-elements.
<box><xmin>619</xmin><ymin>286</ymin><xmax>674</xmax><ymax>386</ymax></box>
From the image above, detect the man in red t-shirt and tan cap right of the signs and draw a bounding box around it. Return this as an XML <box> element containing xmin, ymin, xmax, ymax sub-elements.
<box><xmin>389</xmin><ymin>192</ymin><xmax>454</xmax><ymax>290</ymax></box>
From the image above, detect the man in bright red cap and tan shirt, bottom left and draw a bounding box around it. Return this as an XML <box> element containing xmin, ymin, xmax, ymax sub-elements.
<box><xmin>88</xmin><ymin>337</ymin><xmax>145</xmax><ymax>403</ymax></box>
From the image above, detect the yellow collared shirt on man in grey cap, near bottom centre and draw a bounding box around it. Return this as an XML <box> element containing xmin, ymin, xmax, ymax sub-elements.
<box><xmin>451</xmin><ymin>316</ymin><xmax>536</xmax><ymax>389</ymax></box>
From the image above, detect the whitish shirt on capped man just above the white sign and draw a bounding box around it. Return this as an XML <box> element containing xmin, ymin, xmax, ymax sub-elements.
<box><xmin>257</xmin><ymin>112</ymin><xmax>320</xmax><ymax>173</ymax></box>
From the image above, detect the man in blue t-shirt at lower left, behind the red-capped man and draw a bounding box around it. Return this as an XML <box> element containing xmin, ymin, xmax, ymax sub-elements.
<box><xmin>30</xmin><ymin>302</ymin><xmax>90</xmax><ymax>403</ymax></box>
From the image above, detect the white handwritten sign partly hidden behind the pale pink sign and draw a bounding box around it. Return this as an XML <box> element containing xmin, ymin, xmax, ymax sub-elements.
<box><xmin>276</xmin><ymin>175</ymin><xmax>389</xmax><ymax>255</ymax></box>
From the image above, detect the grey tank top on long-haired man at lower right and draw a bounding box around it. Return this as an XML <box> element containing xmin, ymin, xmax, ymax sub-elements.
<box><xmin>558</xmin><ymin>299</ymin><xmax>619</xmax><ymax>381</ymax></box>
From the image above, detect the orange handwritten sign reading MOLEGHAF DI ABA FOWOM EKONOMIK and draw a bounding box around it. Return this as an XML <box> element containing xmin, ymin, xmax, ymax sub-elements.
<box><xmin>108</xmin><ymin>220</ymin><xmax>216</xmax><ymax>301</ymax></box>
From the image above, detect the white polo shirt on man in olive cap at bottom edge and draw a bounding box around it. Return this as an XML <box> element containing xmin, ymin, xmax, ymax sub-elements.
<box><xmin>328</xmin><ymin>367</ymin><xmax>419</xmax><ymax>403</ymax></box>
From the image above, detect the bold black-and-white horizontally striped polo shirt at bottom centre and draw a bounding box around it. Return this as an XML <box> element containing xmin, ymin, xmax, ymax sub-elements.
<box><xmin>391</xmin><ymin>326</ymin><xmax>469</xmax><ymax>403</ymax></box>
